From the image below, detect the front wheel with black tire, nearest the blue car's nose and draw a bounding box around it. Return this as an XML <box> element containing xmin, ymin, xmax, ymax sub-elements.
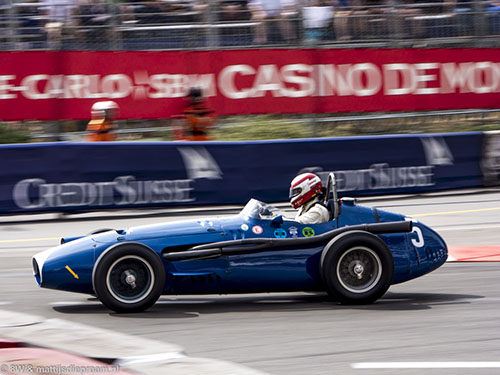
<box><xmin>93</xmin><ymin>244</ymin><xmax>165</xmax><ymax>313</ymax></box>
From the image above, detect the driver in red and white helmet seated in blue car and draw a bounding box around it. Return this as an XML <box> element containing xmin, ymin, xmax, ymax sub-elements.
<box><xmin>290</xmin><ymin>173</ymin><xmax>330</xmax><ymax>224</ymax></box>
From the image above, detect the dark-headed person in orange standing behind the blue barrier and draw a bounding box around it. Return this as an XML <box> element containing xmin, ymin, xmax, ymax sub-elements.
<box><xmin>183</xmin><ymin>87</ymin><xmax>215</xmax><ymax>141</ymax></box>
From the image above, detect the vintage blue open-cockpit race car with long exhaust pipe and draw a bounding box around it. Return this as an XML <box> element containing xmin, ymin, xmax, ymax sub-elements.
<box><xmin>33</xmin><ymin>174</ymin><xmax>448</xmax><ymax>312</ymax></box>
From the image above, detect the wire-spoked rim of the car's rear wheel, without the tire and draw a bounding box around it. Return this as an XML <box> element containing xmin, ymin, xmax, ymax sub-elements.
<box><xmin>337</xmin><ymin>247</ymin><xmax>382</xmax><ymax>293</ymax></box>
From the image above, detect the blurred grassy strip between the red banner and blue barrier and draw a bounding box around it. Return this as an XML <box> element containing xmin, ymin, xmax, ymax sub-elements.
<box><xmin>8</xmin><ymin>109</ymin><xmax>500</xmax><ymax>143</ymax></box>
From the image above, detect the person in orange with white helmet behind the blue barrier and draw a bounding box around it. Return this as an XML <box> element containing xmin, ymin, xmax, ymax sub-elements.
<box><xmin>85</xmin><ymin>101</ymin><xmax>118</xmax><ymax>142</ymax></box>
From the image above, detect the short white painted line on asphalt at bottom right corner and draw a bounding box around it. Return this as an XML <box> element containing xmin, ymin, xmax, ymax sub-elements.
<box><xmin>351</xmin><ymin>362</ymin><xmax>500</xmax><ymax>370</ymax></box>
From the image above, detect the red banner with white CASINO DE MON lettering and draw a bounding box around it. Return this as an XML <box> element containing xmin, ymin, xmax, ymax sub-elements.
<box><xmin>0</xmin><ymin>49</ymin><xmax>500</xmax><ymax>120</ymax></box>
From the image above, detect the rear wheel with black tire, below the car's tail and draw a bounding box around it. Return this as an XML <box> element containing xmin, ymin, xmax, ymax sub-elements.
<box><xmin>320</xmin><ymin>231</ymin><xmax>394</xmax><ymax>305</ymax></box>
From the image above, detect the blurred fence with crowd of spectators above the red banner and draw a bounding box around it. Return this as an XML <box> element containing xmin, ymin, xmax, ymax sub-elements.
<box><xmin>0</xmin><ymin>0</ymin><xmax>500</xmax><ymax>51</ymax></box>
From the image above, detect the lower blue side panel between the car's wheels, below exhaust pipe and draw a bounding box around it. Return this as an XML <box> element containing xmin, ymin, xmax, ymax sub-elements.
<box><xmin>165</xmin><ymin>246</ymin><xmax>323</xmax><ymax>295</ymax></box>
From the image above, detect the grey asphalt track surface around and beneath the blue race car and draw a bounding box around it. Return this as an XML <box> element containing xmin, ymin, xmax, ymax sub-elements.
<box><xmin>0</xmin><ymin>190</ymin><xmax>500</xmax><ymax>375</ymax></box>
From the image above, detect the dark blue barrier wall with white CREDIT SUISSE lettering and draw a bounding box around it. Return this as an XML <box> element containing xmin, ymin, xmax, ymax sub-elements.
<box><xmin>0</xmin><ymin>133</ymin><xmax>483</xmax><ymax>214</ymax></box>
